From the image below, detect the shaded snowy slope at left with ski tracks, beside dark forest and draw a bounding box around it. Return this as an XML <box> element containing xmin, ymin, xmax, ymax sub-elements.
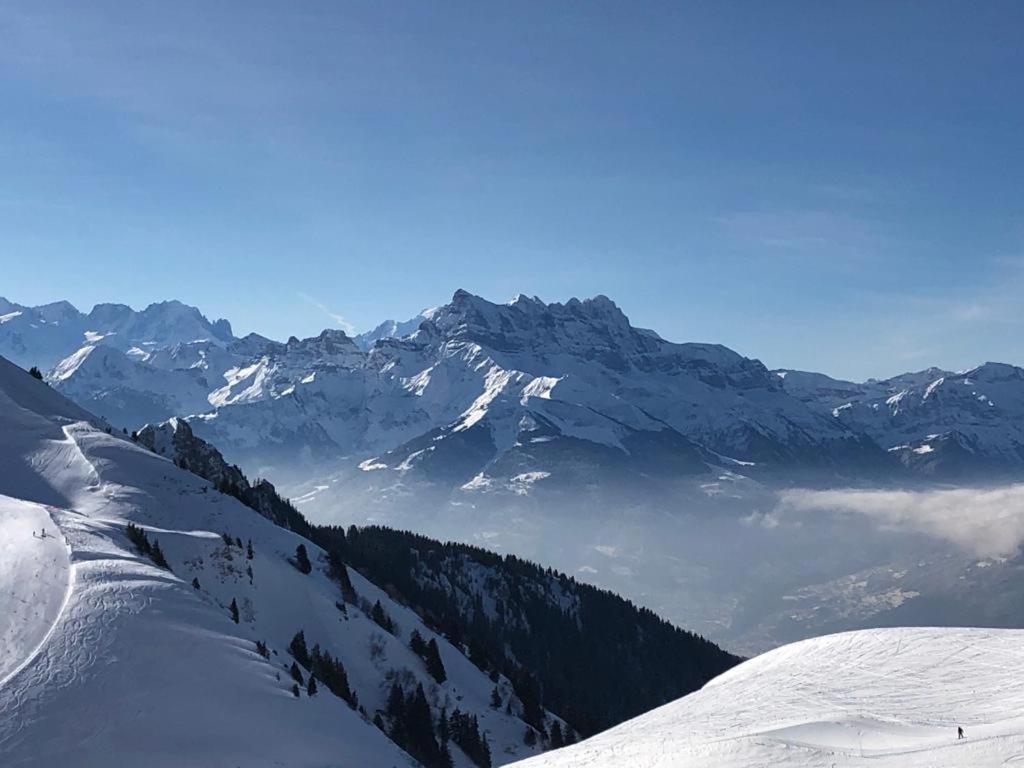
<box><xmin>0</xmin><ymin>358</ymin><xmax>552</xmax><ymax>768</ymax></box>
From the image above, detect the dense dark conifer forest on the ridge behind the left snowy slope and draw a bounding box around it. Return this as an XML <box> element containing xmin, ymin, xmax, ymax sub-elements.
<box><xmin>140</xmin><ymin>430</ymin><xmax>740</xmax><ymax>744</ymax></box>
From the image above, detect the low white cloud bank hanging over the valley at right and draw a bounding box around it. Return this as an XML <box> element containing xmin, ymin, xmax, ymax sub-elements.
<box><xmin>778</xmin><ymin>483</ymin><xmax>1024</xmax><ymax>557</ymax></box>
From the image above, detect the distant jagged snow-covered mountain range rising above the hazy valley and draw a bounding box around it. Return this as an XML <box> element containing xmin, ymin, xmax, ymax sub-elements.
<box><xmin>12</xmin><ymin>291</ymin><xmax>1024</xmax><ymax>492</ymax></box>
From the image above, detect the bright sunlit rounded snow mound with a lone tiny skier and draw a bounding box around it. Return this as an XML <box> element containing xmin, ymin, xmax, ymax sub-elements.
<box><xmin>515</xmin><ymin>628</ymin><xmax>1024</xmax><ymax>768</ymax></box>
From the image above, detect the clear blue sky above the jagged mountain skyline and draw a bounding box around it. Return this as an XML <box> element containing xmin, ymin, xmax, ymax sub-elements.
<box><xmin>0</xmin><ymin>0</ymin><xmax>1024</xmax><ymax>378</ymax></box>
